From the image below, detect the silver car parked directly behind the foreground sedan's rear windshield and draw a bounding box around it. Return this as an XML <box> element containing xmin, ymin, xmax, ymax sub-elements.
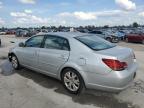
<box><xmin>89</xmin><ymin>30</ymin><xmax>119</xmax><ymax>43</ymax></box>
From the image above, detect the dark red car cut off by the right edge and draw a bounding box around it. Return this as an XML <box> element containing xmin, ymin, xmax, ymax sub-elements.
<box><xmin>126</xmin><ymin>33</ymin><xmax>144</xmax><ymax>44</ymax></box>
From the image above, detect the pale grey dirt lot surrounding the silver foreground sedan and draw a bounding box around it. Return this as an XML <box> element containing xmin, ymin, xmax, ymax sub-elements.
<box><xmin>0</xmin><ymin>36</ymin><xmax>144</xmax><ymax>108</ymax></box>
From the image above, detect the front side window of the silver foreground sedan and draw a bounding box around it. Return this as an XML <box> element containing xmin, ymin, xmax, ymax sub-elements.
<box><xmin>25</xmin><ymin>36</ymin><xmax>44</xmax><ymax>48</ymax></box>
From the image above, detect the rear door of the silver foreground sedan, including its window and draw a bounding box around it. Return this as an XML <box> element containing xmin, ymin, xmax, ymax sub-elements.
<box><xmin>39</xmin><ymin>36</ymin><xmax>70</xmax><ymax>75</ymax></box>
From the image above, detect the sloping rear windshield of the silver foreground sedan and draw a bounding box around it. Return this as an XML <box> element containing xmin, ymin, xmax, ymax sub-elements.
<box><xmin>75</xmin><ymin>35</ymin><xmax>116</xmax><ymax>51</ymax></box>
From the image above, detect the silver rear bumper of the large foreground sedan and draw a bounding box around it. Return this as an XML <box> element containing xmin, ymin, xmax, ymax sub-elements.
<box><xmin>86</xmin><ymin>63</ymin><xmax>138</xmax><ymax>92</ymax></box>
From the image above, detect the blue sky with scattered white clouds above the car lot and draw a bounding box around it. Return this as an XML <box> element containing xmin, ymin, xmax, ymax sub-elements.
<box><xmin>0</xmin><ymin>0</ymin><xmax>144</xmax><ymax>27</ymax></box>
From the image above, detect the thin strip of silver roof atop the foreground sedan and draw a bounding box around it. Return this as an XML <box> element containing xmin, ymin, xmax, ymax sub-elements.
<box><xmin>38</xmin><ymin>32</ymin><xmax>90</xmax><ymax>38</ymax></box>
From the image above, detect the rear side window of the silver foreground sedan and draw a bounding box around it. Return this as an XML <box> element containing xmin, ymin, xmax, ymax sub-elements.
<box><xmin>44</xmin><ymin>36</ymin><xmax>70</xmax><ymax>51</ymax></box>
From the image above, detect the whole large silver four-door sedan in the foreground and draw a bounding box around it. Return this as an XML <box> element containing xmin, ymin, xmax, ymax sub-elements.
<box><xmin>8</xmin><ymin>32</ymin><xmax>137</xmax><ymax>94</ymax></box>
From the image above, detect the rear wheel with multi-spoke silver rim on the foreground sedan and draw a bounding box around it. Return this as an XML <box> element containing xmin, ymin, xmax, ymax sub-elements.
<box><xmin>62</xmin><ymin>68</ymin><xmax>85</xmax><ymax>94</ymax></box>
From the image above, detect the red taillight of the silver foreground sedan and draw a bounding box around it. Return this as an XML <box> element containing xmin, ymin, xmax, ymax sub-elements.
<box><xmin>102</xmin><ymin>59</ymin><xmax>127</xmax><ymax>71</ymax></box>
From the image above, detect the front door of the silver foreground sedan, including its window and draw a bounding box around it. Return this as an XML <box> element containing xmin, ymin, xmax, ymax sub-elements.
<box><xmin>17</xmin><ymin>36</ymin><xmax>44</xmax><ymax>68</ymax></box>
